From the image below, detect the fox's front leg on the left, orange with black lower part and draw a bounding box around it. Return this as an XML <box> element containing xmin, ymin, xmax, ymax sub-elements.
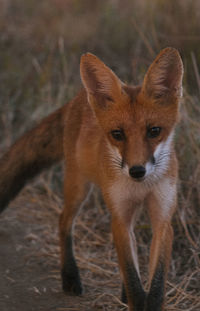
<box><xmin>106</xmin><ymin>202</ymin><xmax>145</xmax><ymax>311</ymax></box>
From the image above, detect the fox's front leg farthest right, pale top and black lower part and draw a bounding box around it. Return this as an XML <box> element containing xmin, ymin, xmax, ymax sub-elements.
<box><xmin>145</xmin><ymin>182</ymin><xmax>176</xmax><ymax>311</ymax></box>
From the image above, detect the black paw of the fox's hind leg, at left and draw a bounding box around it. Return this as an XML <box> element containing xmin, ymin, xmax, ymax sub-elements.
<box><xmin>61</xmin><ymin>270</ymin><xmax>83</xmax><ymax>296</ymax></box>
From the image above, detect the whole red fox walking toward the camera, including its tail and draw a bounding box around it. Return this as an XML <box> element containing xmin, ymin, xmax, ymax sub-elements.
<box><xmin>0</xmin><ymin>48</ymin><xmax>183</xmax><ymax>311</ymax></box>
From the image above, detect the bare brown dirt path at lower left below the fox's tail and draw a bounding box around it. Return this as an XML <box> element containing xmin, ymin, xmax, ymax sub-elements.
<box><xmin>0</xmin><ymin>194</ymin><xmax>72</xmax><ymax>311</ymax></box>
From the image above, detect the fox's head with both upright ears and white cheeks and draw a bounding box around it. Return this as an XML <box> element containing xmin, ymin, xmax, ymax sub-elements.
<box><xmin>80</xmin><ymin>48</ymin><xmax>183</xmax><ymax>185</ymax></box>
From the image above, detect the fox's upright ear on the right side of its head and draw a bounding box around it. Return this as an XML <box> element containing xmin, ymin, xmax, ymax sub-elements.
<box><xmin>142</xmin><ymin>48</ymin><xmax>183</xmax><ymax>101</ymax></box>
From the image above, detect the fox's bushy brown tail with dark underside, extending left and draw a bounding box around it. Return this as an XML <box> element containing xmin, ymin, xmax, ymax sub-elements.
<box><xmin>0</xmin><ymin>106</ymin><xmax>66</xmax><ymax>212</ymax></box>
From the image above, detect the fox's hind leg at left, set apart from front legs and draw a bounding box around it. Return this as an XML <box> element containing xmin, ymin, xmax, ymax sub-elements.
<box><xmin>59</xmin><ymin>168</ymin><xmax>88</xmax><ymax>295</ymax></box>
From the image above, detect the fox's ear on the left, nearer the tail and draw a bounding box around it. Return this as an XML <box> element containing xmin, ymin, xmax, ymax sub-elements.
<box><xmin>80</xmin><ymin>53</ymin><xmax>122</xmax><ymax>107</ymax></box>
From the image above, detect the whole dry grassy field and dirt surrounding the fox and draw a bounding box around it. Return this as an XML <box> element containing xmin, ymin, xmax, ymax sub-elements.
<box><xmin>0</xmin><ymin>0</ymin><xmax>200</xmax><ymax>311</ymax></box>
